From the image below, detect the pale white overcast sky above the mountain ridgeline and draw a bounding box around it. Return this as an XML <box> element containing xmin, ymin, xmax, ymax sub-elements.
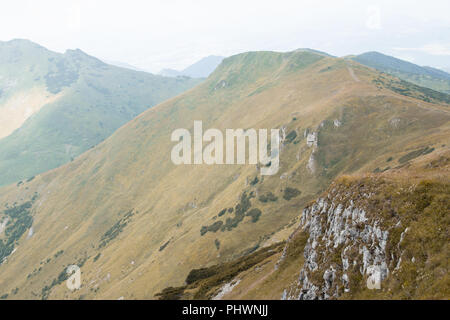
<box><xmin>0</xmin><ymin>0</ymin><xmax>450</xmax><ymax>73</ymax></box>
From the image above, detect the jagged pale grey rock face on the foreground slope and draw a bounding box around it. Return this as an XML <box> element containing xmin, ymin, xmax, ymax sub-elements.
<box><xmin>282</xmin><ymin>182</ymin><xmax>398</xmax><ymax>300</ymax></box>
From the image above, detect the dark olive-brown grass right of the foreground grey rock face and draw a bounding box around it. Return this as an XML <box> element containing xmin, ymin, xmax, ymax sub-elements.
<box><xmin>345</xmin><ymin>180</ymin><xmax>450</xmax><ymax>299</ymax></box>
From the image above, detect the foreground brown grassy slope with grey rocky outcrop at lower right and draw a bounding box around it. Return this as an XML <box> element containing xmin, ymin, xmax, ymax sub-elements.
<box><xmin>171</xmin><ymin>150</ymin><xmax>450</xmax><ymax>299</ymax></box>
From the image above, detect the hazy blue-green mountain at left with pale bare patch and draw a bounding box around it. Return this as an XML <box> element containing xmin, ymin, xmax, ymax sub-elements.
<box><xmin>0</xmin><ymin>40</ymin><xmax>199</xmax><ymax>185</ymax></box>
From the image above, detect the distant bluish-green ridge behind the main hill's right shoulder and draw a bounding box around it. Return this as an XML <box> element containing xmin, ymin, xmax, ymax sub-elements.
<box><xmin>352</xmin><ymin>52</ymin><xmax>450</xmax><ymax>94</ymax></box>
